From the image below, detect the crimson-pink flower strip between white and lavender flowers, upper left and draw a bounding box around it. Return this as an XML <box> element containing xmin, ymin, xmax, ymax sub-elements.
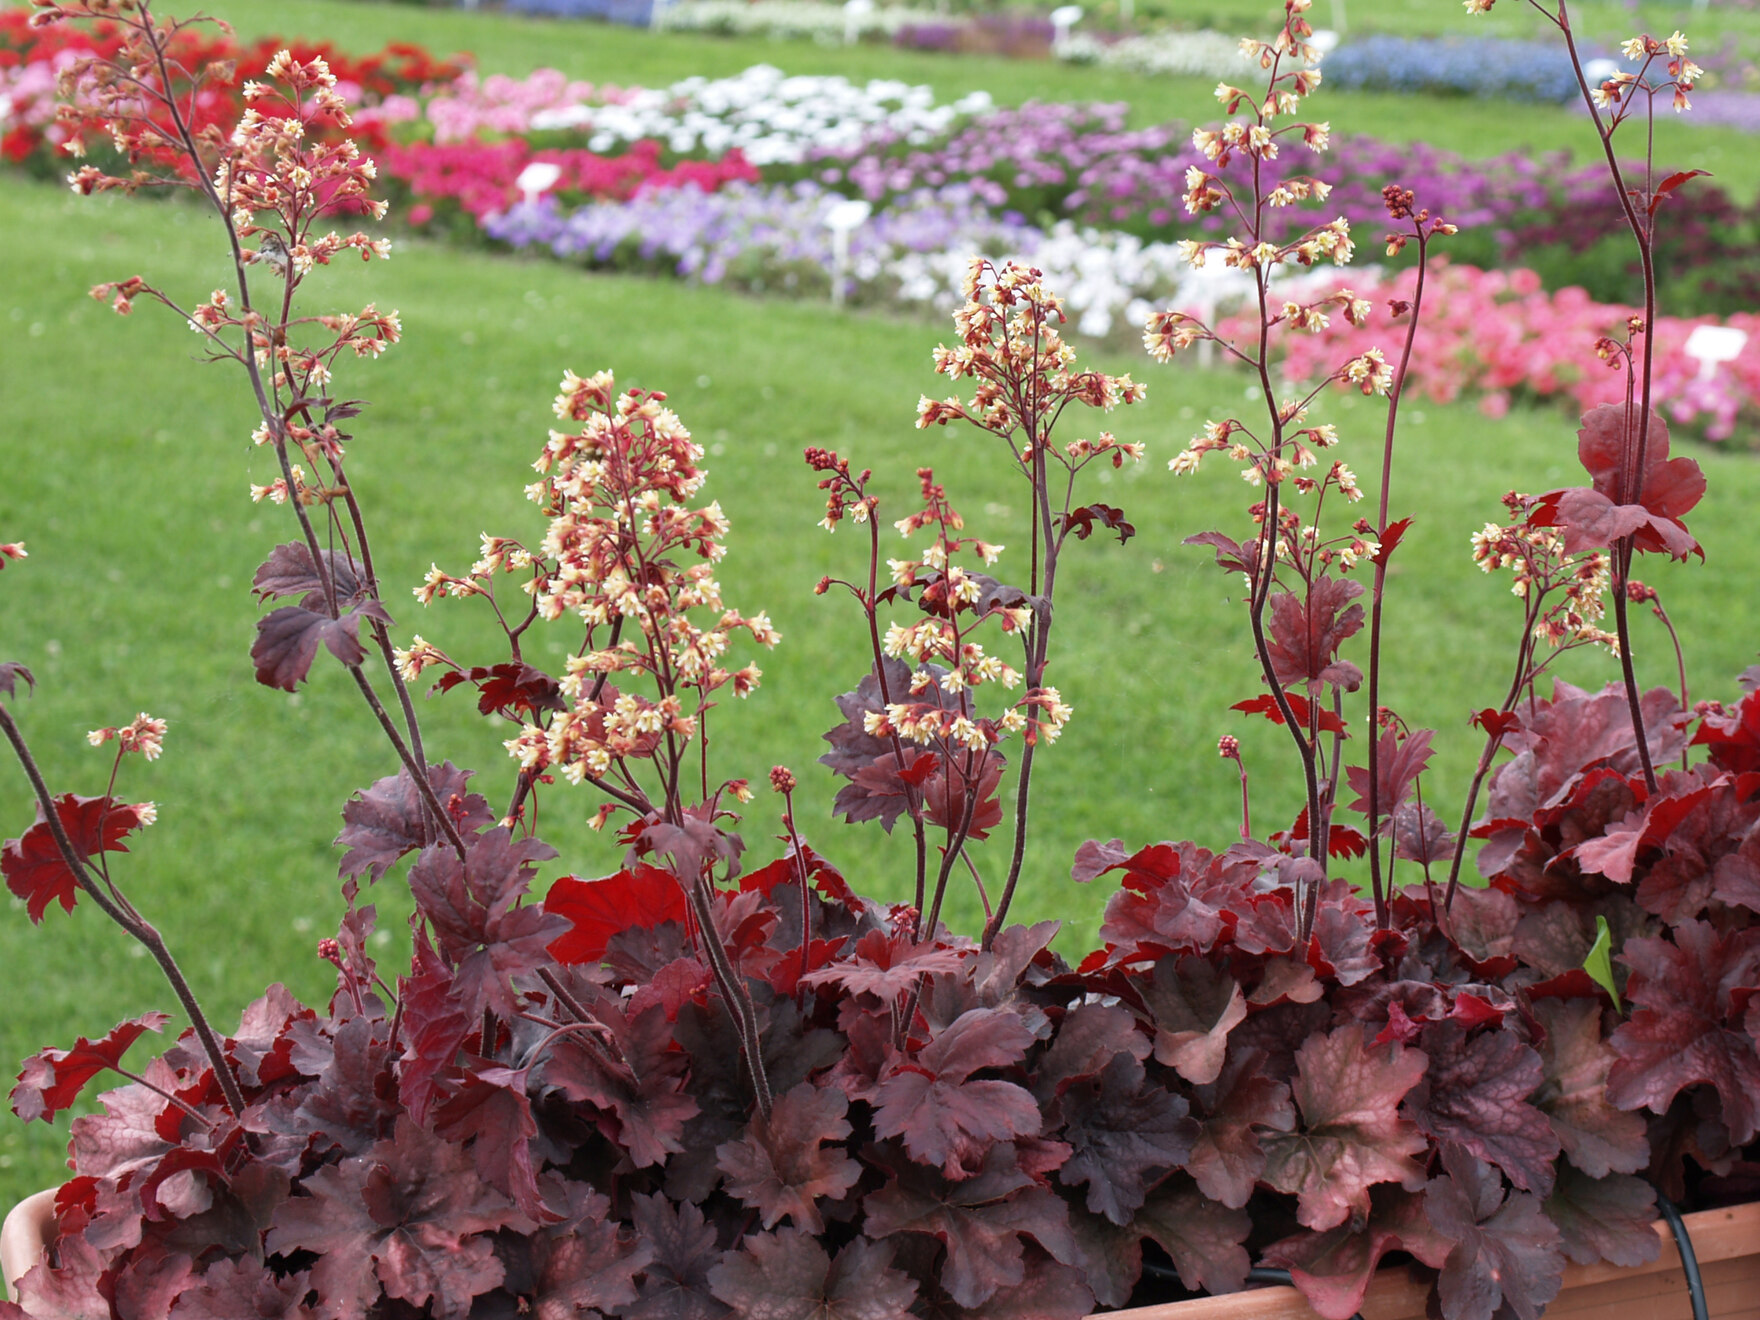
<box><xmin>378</xmin><ymin>139</ymin><xmax>759</xmax><ymax>224</ymax></box>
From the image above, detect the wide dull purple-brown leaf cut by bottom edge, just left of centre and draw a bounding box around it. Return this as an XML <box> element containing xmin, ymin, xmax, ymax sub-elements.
<box><xmin>709</xmin><ymin>1228</ymin><xmax>917</xmax><ymax>1320</ymax></box>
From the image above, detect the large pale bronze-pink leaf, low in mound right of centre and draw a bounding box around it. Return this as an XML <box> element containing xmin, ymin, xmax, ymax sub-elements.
<box><xmin>1260</xmin><ymin>1024</ymin><xmax>1429</xmax><ymax>1230</ymax></box>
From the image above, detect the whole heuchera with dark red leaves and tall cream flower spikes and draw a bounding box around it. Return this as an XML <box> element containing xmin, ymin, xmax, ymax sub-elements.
<box><xmin>0</xmin><ymin>0</ymin><xmax>1760</xmax><ymax>1320</ymax></box>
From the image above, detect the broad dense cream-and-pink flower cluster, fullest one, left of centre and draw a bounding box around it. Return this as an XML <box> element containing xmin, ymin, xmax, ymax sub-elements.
<box><xmin>425</xmin><ymin>371</ymin><xmax>780</xmax><ymax>783</ymax></box>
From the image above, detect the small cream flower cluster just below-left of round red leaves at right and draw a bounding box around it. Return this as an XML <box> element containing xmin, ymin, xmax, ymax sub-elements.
<box><xmin>1473</xmin><ymin>491</ymin><xmax>1619</xmax><ymax>655</ymax></box>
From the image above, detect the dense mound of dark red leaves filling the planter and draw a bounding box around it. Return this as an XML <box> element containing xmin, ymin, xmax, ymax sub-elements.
<box><xmin>4</xmin><ymin>685</ymin><xmax>1760</xmax><ymax>1320</ymax></box>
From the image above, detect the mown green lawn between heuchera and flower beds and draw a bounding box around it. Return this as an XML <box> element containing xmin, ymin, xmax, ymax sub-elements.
<box><xmin>0</xmin><ymin>4</ymin><xmax>1760</xmax><ymax>1204</ymax></box>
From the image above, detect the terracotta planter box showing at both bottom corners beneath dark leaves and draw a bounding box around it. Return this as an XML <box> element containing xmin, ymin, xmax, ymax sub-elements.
<box><xmin>0</xmin><ymin>1192</ymin><xmax>1760</xmax><ymax>1320</ymax></box>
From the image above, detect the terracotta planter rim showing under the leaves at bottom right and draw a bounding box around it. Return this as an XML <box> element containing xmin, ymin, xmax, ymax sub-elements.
<box><xmin>1089</xmin><ymin>1200</ymin><xmax>1760</xmax><ymax>1320</ymax></box>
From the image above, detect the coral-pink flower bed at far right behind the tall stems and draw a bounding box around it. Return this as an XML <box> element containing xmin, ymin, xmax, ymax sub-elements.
<box><xmin>1220</xmin><ymin>262</ymin><xmax>1760</xmax><ymax>440</ymax></box>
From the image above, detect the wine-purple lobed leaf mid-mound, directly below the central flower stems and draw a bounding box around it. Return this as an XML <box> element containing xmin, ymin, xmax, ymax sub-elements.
<box><xmin>875</xmin><ymin>1008</ymin><xmax>1042</xmax><ymax>1177</ymax></box>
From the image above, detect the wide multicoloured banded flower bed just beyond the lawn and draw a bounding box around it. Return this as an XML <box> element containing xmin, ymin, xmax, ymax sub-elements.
<box><xmin>0</xmin><ymin>7</ymin><xmax>1760</xmax><ymax>438</ymax></box>
